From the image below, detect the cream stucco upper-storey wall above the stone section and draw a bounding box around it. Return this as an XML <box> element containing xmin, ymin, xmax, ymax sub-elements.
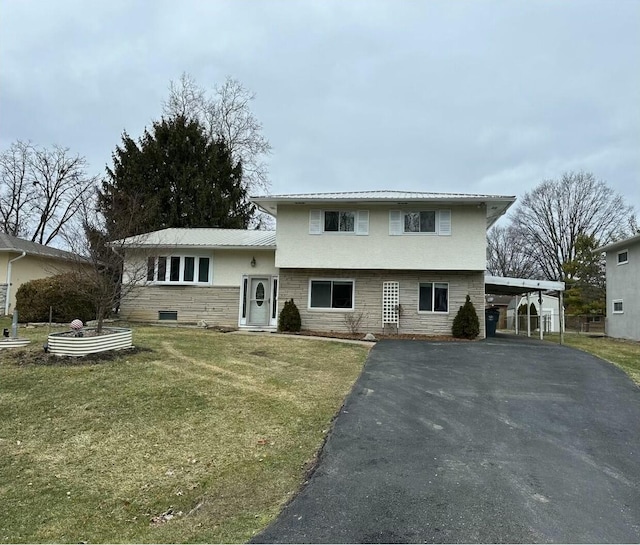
<box><xmin>276</xmin><ymin>203</ymin><xmax>486</xmax><ymax>271</ymax></box>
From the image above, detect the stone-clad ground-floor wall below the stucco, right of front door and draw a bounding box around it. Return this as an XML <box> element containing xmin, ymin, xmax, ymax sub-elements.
<box><xmin>278</xmin><ymin>269</ymin><xmax>484</xmax><ymax>337</ymax></box>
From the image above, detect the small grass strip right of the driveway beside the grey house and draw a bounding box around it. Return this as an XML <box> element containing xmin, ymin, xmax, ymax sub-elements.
<box><xmin>545</xmin><ymin>333</ymin><xmax>640</xmax><ymax>385</ymax></box>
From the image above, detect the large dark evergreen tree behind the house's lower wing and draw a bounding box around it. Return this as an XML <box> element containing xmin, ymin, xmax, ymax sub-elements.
<box><xmin>98</xmin><ymin>115</ymin><xmax>254</xmax><ymax>237</ymax></box>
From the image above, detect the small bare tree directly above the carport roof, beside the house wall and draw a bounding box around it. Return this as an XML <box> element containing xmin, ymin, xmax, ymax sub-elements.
<box><xmin>487</xmin><ymin>225</ymin><xmax>540</xmax><ymax>278</ymax></box>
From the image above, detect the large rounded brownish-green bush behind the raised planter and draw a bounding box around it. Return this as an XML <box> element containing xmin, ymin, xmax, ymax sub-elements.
<box><xmin>16</xmin><ymin>274</ymin><xmax>96</xmax><ymax>323</ymax></box>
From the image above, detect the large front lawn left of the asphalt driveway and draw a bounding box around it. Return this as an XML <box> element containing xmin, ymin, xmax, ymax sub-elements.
<box><xmin>0</xmin><ymin>323</ymin><xmax>367</xmax><ymax>543</ymax></box>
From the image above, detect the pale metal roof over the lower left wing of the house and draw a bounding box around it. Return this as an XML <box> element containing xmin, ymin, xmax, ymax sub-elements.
<box><xmin>118</xmin><ymin>228</ymin><xmax>276</xmax><ymax>250</ymax></box>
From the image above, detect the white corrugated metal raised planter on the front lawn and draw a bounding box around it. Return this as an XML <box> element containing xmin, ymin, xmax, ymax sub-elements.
<box><xmin>47</xmin><ymin>327</ymin><xmax>132</xmax><ymax>356</ymax></box>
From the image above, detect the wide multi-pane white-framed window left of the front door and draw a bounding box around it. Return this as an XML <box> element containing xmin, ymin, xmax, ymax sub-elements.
<box><xmin>147</xmin><ymin>255</ymin><xmax>211</xmax><ymax>284</ymax></box>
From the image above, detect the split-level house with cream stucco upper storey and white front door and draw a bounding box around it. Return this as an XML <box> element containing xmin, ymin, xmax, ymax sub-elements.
<box><xmin>121</xmin><ymin>191</ymin><xmax>515</xmax><ymax>335</ymax></box>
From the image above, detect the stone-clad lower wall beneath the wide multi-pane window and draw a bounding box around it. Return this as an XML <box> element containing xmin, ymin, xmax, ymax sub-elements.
<box><xmin>120</xmin><ymin>286</ymin><xmax>240</xmax><ymax>327</ymax></box>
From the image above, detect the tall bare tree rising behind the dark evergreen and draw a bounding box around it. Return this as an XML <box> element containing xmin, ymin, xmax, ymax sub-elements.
<box><xmin>163</xmin><ymin>73</ymin><xmax>271</xmax><ymax>193</ymax></box>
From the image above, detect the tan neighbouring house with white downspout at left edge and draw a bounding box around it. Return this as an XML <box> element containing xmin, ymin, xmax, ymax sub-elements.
<box><xmin>0</xmin><ymin>233</ymin><xmax>85</xmax><ymax>314</ymax></box>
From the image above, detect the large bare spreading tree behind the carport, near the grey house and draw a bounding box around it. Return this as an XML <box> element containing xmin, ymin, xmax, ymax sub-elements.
<box><xmin>513</xmin><ymin>172</ymin><xmax>635</xmax><ymax>281</ymax></box>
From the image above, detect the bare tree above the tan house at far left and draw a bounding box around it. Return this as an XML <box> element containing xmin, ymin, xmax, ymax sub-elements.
<box><xmin>0</xmin><ymin>141</ymin><xmax>96</xmax><ymax>244</ymax></box>
